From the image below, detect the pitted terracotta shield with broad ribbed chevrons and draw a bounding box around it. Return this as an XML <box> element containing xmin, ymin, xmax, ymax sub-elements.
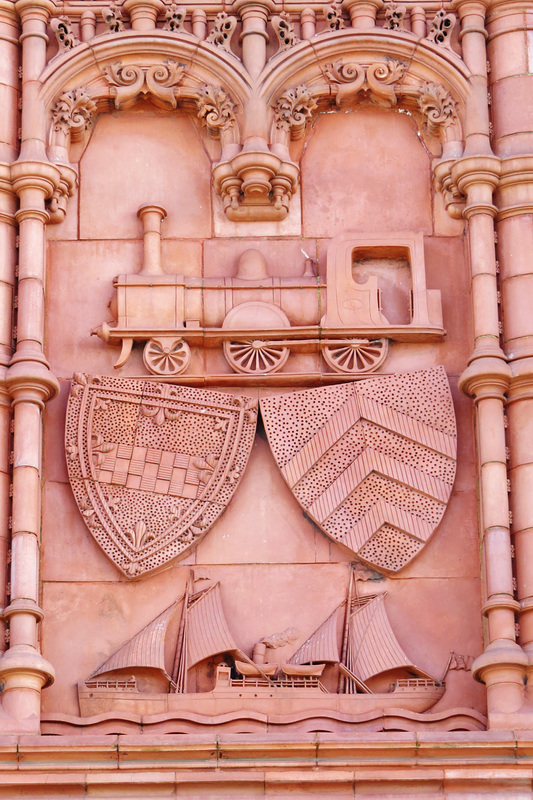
<box><xmin>261</xmin><ymin>367</ymin><xmax>457</xmax><ymax>573</ymax></box>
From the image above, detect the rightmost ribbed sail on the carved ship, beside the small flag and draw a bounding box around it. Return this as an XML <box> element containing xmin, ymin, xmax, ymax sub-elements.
<box><xmin>346</xmin><ymin>593</ymin><xmax>431</xmax><ymax>681</ymax></box>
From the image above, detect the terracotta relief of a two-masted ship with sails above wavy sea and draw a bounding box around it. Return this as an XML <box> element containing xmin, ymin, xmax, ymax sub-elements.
<box><xmin>78</xmin><ymin>576</ymin><xmax>445</xmax><ymax>721</ymax></box>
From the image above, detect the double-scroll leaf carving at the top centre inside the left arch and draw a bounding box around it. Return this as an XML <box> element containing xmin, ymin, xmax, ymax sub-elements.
<box><xmin>102</xmin><ymin>60</ymin><xmax>185</xmax><ymax>108</ymax></box>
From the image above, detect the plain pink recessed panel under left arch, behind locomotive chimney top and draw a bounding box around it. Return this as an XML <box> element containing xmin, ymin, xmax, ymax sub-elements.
<box><xmin>80</xmin><ymin>108</ymin><xmax>211</xmax><ymax>239</ymax></box>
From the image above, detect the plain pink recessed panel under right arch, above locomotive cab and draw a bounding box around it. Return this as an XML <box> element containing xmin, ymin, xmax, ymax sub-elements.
<box><xmin>301</xmin><ymin>106</ymin><xmax>432</xmax><ymax>238</ymax></box>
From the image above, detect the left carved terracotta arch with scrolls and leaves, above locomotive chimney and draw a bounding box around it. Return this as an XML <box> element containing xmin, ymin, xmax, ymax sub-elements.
<box><xmin>40</xmin><ymin>32</ymin><xmax>250</xmax><ymax>163</ymax></box>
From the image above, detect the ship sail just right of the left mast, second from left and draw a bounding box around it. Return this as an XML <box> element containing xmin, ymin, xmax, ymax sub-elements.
<box><xmin>184</xmin><ymin>583</ymin><xmax>249</xmax><ymax>669</ymax></box>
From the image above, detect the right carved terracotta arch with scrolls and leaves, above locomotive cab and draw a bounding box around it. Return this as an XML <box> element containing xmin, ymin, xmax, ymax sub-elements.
<box><xmin>262</xmin><ymin>29</ymin><xmax>470</xmax><ymax>155</ymax></box>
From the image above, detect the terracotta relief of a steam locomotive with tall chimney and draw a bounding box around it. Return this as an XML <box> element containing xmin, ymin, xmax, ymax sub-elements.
<box><xmin>93</xmin><ymin>205</ymin><xmax>445</xmax><ymax>378</ymax></box>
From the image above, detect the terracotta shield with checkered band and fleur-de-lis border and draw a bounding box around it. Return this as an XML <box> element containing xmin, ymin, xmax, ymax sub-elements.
<box><xmin>66</xmin><ymin>373</ymin><xmax>257</xmax><ymax>578</ymax></box>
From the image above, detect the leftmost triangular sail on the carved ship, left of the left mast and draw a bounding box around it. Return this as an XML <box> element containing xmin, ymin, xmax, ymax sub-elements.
<box><xmin>88</xmin><ymin>603</ymin><xmax>177</xmax><ymax>681</ymax></box>
